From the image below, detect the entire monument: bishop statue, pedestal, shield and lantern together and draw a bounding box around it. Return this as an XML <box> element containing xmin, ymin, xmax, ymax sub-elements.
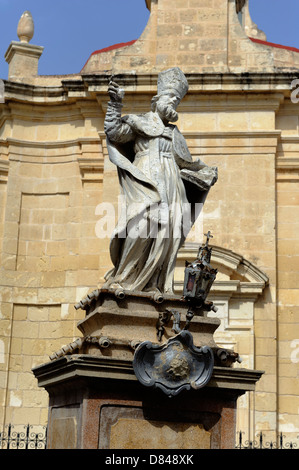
<box><xmin>34</xmin><ymin>67</ymin><xmax>262</xmax><ymax>449</ymax></box>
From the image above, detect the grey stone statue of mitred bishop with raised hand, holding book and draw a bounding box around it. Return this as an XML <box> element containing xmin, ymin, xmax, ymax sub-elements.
<box><xmin>103</xmin><ymin>67</ymin><xmax>217</xmax><ymax>294</ymax></box>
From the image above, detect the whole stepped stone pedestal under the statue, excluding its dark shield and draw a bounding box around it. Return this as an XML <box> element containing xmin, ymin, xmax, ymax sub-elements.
<box><xmin>33</xmin><ymin>291</ymin><xmax>262</xmax><ymax>449</ymax></box>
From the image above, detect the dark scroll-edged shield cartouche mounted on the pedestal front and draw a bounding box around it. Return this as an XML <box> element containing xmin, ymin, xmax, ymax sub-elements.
<box><xmin>133</xmin><ymin>331</ymin><xmax>214</xmax><ymax>397</ymax></box>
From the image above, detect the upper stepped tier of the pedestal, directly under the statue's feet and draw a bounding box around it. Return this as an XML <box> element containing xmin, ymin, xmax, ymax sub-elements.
<box><xmin>51</xmin><ymin>290</ymin><xmax>238</xmax><ymax>365</ymax></box>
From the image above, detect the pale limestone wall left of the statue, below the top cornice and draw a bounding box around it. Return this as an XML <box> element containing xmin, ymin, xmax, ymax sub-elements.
<box><xmin>0</xmin><ymin>95</ymin><xmax>103</xmax><ymax>424</ymax></box>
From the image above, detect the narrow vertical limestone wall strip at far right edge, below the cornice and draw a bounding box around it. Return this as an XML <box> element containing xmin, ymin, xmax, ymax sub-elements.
<box><xmin>276</xmin><ymin>101</ymin><xmax>299</xmax><ymax>438</ymax></box>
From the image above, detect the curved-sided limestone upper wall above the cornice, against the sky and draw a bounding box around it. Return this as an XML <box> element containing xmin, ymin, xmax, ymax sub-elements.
<box><xmin>82</xmin><ymin>0</ymin><xmax>299</xmax><ymax>73</ymax></box>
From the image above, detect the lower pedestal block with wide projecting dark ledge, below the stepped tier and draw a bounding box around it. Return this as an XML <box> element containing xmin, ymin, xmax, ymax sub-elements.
<box><xmin>34</xmin><ymin>355</ymin><xmax>261</xmax><ymax>449</ymax></box>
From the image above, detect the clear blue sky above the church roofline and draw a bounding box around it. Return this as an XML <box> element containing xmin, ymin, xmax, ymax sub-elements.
<box><xmin>0</xmin><ymin>0</ymin><xmax>299</xmax><ymax>79</ymax></box>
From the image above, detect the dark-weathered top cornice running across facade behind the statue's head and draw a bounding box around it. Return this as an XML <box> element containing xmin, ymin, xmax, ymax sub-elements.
<box><xmin>0</xmin><ymin>71</ymin><xmax>299</xmax><ymax>103</ymax></box>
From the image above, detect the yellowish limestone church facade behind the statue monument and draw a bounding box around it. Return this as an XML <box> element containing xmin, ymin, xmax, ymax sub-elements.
<box><xmin>0</xmin><ymin>0</ymin><xmax>299</xmax><ymax>446</ymax></box>
